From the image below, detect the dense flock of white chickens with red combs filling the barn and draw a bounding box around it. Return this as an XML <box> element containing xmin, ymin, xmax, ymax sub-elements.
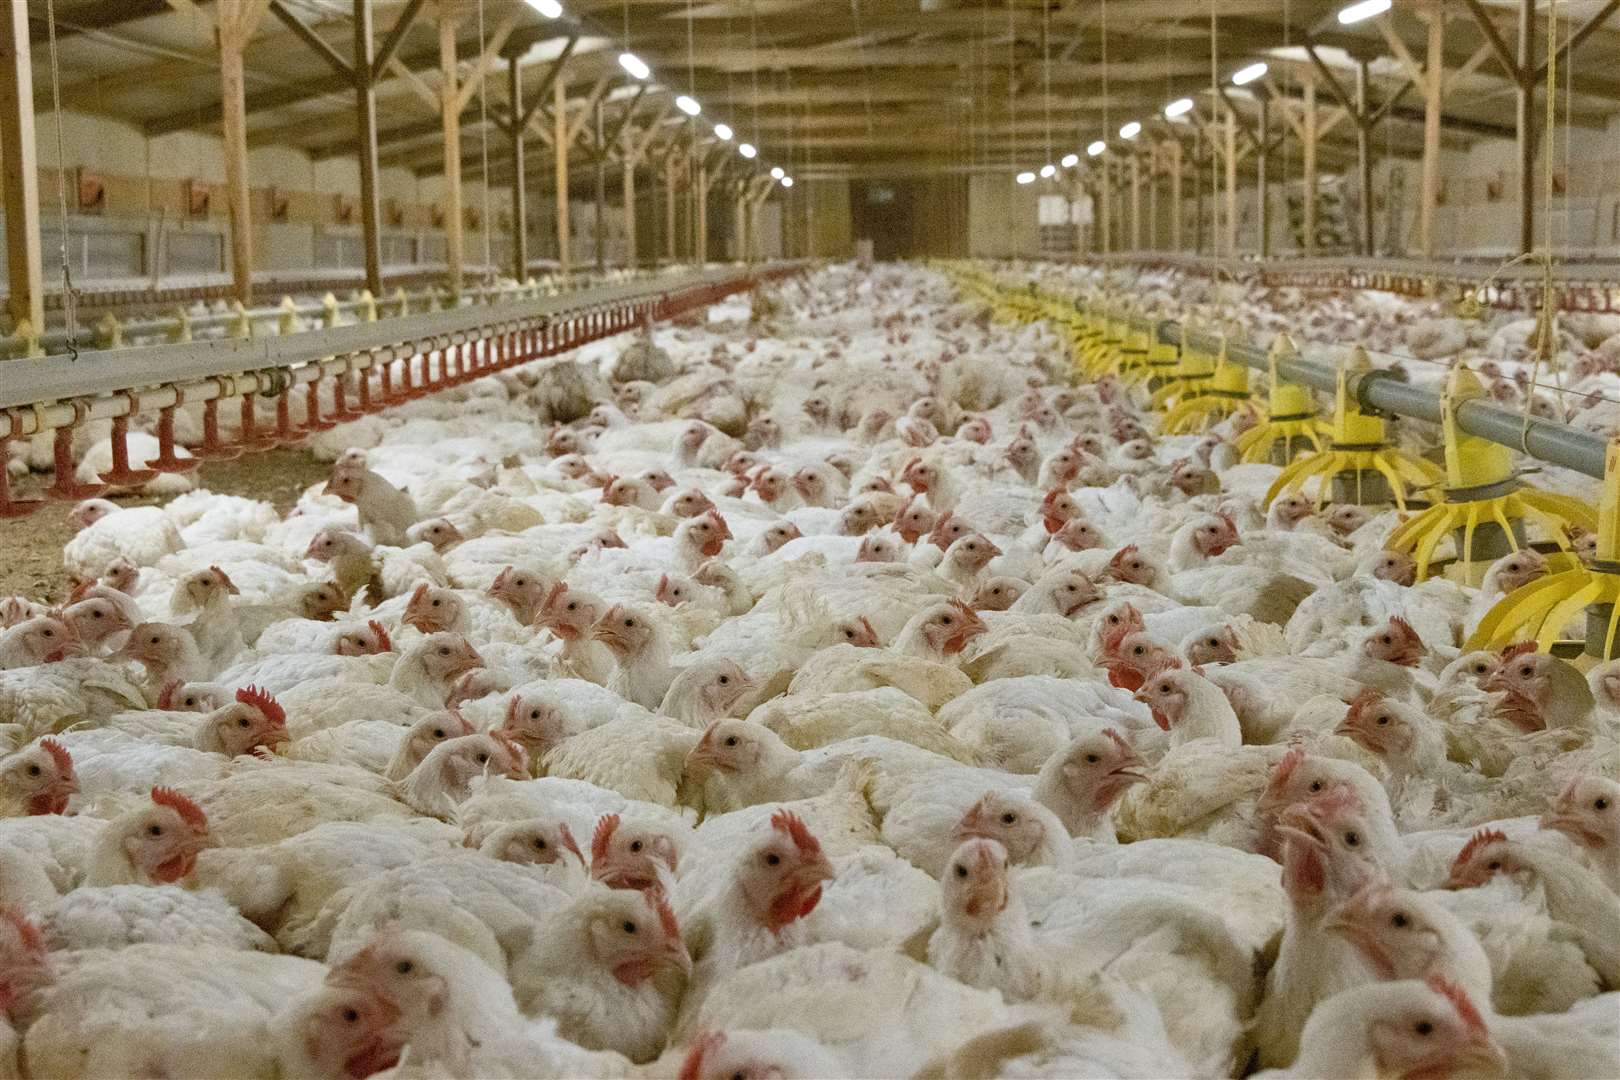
<box><xmin>0</xmin><ymin>267</ymin><xmax>1620</xmax><ymax>1080</ymax></box>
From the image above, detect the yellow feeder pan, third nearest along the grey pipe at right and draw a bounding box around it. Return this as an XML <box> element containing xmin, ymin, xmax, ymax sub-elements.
<box><xmin>1265</xmin><ymin>345</ymin><xmax>1445</xmax><ymax>513</ymax></box>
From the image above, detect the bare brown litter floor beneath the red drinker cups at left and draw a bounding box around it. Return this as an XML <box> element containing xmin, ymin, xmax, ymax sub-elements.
<box><xmin>0</xmin><ymin>447</ymin><xmax>330</xmax><ymax>604</ymax></box>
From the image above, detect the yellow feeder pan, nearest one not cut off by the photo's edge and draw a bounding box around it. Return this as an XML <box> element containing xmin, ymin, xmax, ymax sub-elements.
<box><xmin>1385</xmin><ymin>364</ymin><xmax>1597</xmax><ymax>585</ymax></box>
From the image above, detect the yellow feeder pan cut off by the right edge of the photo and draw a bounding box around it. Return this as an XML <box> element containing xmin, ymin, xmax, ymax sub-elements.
<box><xmin>1463</xmin><ymin>439</ymin><xmax>1620</xmax><ymax>659</ymax></box>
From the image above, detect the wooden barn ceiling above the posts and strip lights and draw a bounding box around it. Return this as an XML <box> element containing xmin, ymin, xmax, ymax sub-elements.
<box><xmin>31</xmin><ymin>0</ymin><xmax>1620</xmax><ymax>183</ymax></box>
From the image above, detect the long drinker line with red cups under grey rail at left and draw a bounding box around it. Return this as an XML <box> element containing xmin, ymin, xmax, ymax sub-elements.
<box><xmin>0</xmin><ymin>262</ymin><xmax>808</xmax><ymax>518</ymax></box>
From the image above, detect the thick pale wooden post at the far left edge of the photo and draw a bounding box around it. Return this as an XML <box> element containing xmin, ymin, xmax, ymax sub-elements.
<box><xmin>0</xmin><ymin>3</ymin><xmax>43</xmax><ymax>335</ymax></box>
